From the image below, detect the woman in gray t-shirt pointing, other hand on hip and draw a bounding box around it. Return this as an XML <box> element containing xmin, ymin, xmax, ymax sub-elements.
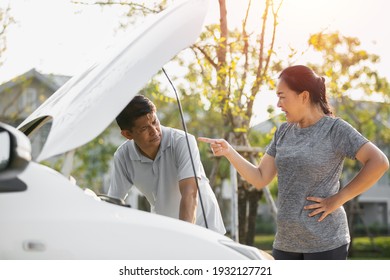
<box><xmin>199</xmin><ymin>65</ymin><xmax>389</xmax><ymax>260</ymax></box>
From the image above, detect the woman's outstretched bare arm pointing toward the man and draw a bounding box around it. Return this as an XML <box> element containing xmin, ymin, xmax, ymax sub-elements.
<box><xmin>198</xmin><ymin>137</ymin><xmax>277</xmax><ymax>189</ymax></box>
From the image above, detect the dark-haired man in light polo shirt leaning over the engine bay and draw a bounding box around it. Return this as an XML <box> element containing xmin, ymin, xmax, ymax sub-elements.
<box><xmin>108</xmin><ymin>95</ymin><xmax>226</xmax><ymax>234</ymax></box>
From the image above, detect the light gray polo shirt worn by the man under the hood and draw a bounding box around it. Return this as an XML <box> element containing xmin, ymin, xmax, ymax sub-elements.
<box><xmin>108</xmin><ymin>126</ymin><xmax>226</xmax><ymax>234</ymax></box>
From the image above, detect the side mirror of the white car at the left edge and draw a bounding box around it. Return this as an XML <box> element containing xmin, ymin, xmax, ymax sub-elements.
<box><xmin>0</xmin><ymin>123</ymin><xmax>31</xmax><ymax>181</ymax></box>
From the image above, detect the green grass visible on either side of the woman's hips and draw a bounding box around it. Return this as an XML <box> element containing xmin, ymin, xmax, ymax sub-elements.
<box><xmin>254</xmin><ymin>235</ymin><xmax>390</xmax><ymax>260</ymax></box>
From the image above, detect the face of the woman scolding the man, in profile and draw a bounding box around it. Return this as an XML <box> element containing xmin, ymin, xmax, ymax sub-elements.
<box><xmin>276</xmin><ymin>80</ymin><xmax>305</xmax><ymax>123</ymax></box>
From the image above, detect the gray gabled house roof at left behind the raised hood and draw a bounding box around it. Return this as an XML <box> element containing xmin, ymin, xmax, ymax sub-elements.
<box><xmin>0</xmin><ymin>68</ymin><xmax>70</xmax><ymax>93</ymax></box>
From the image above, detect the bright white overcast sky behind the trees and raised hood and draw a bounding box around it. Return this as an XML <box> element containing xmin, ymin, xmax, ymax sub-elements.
<box><xmin>0</xmin><ymin>0</ymin><xmax>390</xmax><ymax>122</ymax></box>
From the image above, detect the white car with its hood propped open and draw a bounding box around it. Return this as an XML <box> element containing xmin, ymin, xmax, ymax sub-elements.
<box><xmin>0</xmin><ymin>0</ymin><xmax>272</xmax><ymax>260</ymax></box>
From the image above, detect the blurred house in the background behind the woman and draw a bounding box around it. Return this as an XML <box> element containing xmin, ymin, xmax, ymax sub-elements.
<box><xmin>251</xmin><ymin>105</ymin><xmax>390</xmax><ymax>232</ymax></box>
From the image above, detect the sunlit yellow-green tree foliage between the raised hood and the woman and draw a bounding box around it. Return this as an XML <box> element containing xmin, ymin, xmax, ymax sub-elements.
<box><xmin>187</xmin><ymin>0</ymin><xmax>280</xmax><ymax>136</ymax></box>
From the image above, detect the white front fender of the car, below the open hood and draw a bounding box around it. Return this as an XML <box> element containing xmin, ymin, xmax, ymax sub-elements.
<box><xmin>0</xmin><ymin>162</ymin><xmax>261</xmax><ymax>260</ymax></box>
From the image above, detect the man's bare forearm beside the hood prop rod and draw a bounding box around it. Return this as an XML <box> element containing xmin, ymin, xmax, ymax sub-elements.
<box><xmin>179</xmin><ymin>177</ymin><xmax>198</xmax><ymax>224</ymax></box>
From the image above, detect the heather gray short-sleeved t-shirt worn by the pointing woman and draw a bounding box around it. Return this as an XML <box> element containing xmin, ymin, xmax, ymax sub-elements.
<box><xmin>267</xmin><ymin>116</ymin><xmax>368</xmax><ymax>253</ymax></box>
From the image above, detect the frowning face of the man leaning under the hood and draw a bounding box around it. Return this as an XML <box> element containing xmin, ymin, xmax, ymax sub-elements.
<box><xmin>122</xmin><ymin>113</ymin><xmax>162</xmax><ymax>152</ymax></box>
